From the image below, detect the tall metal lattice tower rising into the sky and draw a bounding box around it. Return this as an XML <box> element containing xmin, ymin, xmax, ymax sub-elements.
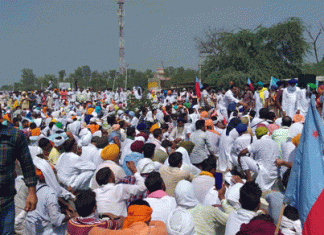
<box><xmin>117</xmin><ymin>0</ymin><xmax>126</xmax><ymax>74</ymax></box>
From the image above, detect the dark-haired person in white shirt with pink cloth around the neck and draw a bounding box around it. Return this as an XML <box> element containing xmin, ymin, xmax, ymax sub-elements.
<box><xmin>144</xmin><ymin>172</ymin><xmax>177</xmax><ymax>223</ymax></box>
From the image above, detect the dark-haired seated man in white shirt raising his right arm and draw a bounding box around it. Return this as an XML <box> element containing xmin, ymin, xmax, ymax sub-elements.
<box><xmin>94</xmin><ymin>161</ymin><xmax>146</xmax><ymax>216</ymax></box>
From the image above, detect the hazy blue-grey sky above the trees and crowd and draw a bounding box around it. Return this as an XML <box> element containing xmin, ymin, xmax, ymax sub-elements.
<box><xmin>0</xmin><ymin>0</ymin><xmax>324</xmax><ymax>87</ymax></box>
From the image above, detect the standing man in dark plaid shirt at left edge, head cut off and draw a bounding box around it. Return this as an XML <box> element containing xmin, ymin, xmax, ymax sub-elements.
<box><xmin>0</xmin><ymin>108</ymin><xmax>37</xmax><ymax>235</ymax></box>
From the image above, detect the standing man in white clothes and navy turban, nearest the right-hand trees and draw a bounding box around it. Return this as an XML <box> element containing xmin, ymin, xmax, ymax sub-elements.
<box><xmin>282</xmin><ymin>79</ymin><xmax>299</xmax><ymax>118</ymax></box>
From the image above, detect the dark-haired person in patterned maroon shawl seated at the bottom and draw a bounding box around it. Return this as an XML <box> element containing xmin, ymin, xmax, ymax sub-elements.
<box><xmin>67</xmin><ymin>189</ymin><xmax>125</xmax><ymax>235</ymax></box>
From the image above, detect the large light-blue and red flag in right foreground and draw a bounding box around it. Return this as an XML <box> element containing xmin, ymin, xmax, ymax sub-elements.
<box><xmin>284</xmin><ymin>95</ymin><xmax>324</xmax><ymax>235</ymax></box>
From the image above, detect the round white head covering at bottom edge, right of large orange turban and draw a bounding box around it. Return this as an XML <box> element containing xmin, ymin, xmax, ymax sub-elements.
<box><xmin>166</xmin><ymin>207</ymin><xmax>195</xmax><ymax>235</ymax></box>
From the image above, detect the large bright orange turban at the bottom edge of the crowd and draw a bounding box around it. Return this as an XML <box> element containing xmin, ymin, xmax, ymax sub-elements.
<box><xmin>123</xmin><ymin>205</ymin><xmax>153</xmax><ymax>229</ymax></box>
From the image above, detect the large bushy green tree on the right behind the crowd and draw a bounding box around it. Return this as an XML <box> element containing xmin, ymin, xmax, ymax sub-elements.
<box><xmin>195</xmin><ymin>18</ymin><xmax>309</xmax><ymax>89</ymax></box>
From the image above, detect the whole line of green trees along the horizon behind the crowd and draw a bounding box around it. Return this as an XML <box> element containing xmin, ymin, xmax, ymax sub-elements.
<box><xmin>1</xmin><ymin>18</ymin><xmax>324</xmax><ymax>91</ymax></box>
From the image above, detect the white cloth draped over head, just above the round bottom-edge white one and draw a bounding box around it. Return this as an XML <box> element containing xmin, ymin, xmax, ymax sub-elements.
<box><xmin>174</xmin><ymin>180</ymin><xmax>199</xmax><ymax>209</ymax></box>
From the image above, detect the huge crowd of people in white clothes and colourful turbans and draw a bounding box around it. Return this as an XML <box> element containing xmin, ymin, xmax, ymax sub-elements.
<box><xmin>0</xmin><ymin>79</ymin><xmax>318</xmax><ymax>235</ymax></box>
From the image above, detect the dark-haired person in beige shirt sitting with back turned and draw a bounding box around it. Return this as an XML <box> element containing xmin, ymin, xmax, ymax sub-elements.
<box><xmin>160</xmin><ymin>152</ymin><xmax>193</xmax><ymax>196</ymax></box>
